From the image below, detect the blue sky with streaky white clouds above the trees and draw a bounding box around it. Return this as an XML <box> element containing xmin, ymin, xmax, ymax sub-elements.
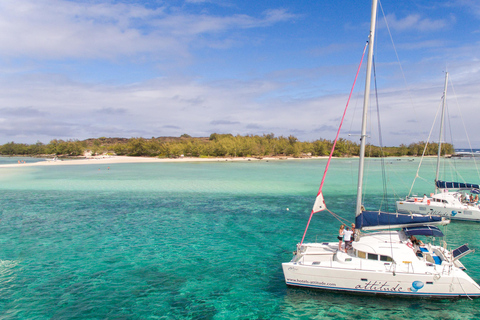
<box><xmin>0</xmin><ymin>0</ymin><xmax>480</xmax><ymax>147</ymax></box>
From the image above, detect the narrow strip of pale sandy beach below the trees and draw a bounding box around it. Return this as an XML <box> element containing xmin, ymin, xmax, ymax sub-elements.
<box><xmin>0</xmin><ymin>156</ymin><xmax>334</xmax><ymax>168</ymax></box>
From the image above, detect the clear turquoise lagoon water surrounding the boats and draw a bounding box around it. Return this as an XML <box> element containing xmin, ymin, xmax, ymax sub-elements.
<box><xmin>0</xmin><ymin>159</ymin><xmax>480</xmax><ymax>319</ymax></box>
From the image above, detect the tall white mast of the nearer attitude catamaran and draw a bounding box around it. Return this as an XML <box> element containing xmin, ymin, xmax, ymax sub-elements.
<box><xmin>355</xmin><ymin>0</ymin><xmax>377</xmax><ymax>217</ymax></box>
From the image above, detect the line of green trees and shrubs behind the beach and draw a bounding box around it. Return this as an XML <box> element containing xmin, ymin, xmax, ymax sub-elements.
<box><xmin>0</xmin><ymin>133</ymin><xmax>454</xmax><ymax>158</ymax></box>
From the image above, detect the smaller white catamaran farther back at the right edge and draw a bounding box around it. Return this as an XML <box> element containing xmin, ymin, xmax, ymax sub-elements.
<box><xmin>396</xmin><ymin>72</ymin><xmax>480</xmax><ymax>221</ymax></box>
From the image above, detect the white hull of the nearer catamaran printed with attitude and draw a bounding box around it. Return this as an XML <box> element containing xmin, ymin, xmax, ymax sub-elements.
<box><xmin>282</xmin><ymin>243</ymin><xmax>480</xmax><ymax>299</ymax></box>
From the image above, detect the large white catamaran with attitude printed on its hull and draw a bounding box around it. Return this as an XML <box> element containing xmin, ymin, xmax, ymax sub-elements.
<box><xmin>282</xmin><ymin>0</ymin><xmax>480</xmax><ymax>298</ymax></box>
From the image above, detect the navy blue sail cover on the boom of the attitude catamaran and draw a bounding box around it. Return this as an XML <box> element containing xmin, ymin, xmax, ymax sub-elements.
<box><xmin>355</xmin><ymin>211</ymin><xmax>442</xmax><ymax>229</ymax></box>
